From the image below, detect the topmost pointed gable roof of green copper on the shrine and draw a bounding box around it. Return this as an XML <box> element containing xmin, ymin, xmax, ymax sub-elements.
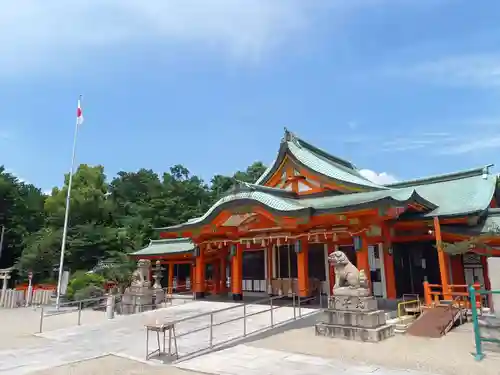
<box><xmin>256</xmin><ymin>129</ymin><xmax>387</xmax><ymax>190</ymax></box>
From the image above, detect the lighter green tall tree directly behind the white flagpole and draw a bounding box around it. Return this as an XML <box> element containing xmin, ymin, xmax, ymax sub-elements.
<box><xmin>17</xmin><ymin>165</ymin><xmax>120</xmax><ymax>280</ymax></box>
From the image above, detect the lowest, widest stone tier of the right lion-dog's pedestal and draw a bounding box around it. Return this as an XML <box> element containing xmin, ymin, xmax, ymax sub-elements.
<box><xmin>315</xmin><ymin>323</ymin><xmax>394</xmax><ymax>342</ymax></box>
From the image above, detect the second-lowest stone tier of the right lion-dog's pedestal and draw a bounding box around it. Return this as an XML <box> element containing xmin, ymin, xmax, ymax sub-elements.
<box><xmin>321</xmin><ymin>309</ymin><xmax>386</xmax><ymax>328</ymax></box>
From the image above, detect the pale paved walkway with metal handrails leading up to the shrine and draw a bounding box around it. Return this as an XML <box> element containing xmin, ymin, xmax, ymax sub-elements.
<box><xmin>0</xmin><ymin>301</ymin><xmax>316</xmax><ymax>375</ymax></box>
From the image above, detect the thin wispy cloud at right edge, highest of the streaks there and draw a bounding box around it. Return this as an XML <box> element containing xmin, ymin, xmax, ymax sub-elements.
<box><xmin>386</xmin><ymin>53</ymin><xmax>500</xmax><ymax>87</ymax></box>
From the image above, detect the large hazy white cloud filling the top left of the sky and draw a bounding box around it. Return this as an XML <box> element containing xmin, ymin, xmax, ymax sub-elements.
<box><xmin>0</xmin><ymin>0</ymin><xmax>327</xmax><ymax>74</ymax></box>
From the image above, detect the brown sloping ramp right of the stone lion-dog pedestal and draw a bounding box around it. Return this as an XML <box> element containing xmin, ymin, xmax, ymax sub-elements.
<box><xmin>406</xmin><ymin>305</ymin><xmax>462</xmax><ymax>338</ymax></box>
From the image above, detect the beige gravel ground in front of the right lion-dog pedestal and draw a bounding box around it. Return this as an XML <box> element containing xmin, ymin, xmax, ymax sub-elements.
<box><xmin>247</xmin><ymin>324</ymin><xmax>500</xmax><ymax>375</ymax></box>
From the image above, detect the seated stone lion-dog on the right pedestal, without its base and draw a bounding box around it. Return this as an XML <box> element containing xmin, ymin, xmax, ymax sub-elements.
<box><xmin>328</xmin><ymin>250</ymin><xmax>369</xmax><ymax>289</ymax></box>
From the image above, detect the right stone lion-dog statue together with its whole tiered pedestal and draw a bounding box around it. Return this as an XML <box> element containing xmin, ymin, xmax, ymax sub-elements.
<box><xmin>315</xmin><ymin>251</ymin><xmax>394</xmax><ymax>342</ymax></box>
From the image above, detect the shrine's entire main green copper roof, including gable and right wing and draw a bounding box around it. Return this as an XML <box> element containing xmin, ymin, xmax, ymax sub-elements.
<box><xmin>157</xmin><ymin>130</ymin><xmax>498</xmax><ymax>232</ymax></box>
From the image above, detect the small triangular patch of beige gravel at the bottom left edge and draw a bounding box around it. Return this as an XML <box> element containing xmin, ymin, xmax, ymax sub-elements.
<box><xmin>26</xmin><ymin>355</ymin><xmax>200</xmax><ymax>375</ymax></box>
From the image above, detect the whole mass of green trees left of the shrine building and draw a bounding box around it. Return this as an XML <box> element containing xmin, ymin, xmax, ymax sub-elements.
<box><xmin>0</xmin><ymin>162</ymin><xmax>265</xmax><ymax>285</ymax></box>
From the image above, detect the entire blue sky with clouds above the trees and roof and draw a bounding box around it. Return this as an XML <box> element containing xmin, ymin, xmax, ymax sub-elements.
<box><xmin>0</xmin><ymin>0</ymin><xmax>500</xmax><ymax>190</ymax></box>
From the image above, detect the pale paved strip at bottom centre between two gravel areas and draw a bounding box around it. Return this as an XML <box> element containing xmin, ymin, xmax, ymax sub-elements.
<box><xmin>175</xmin><ymin>344</ymin><xmax>431</xmax><ymax>375</ymax></box>
